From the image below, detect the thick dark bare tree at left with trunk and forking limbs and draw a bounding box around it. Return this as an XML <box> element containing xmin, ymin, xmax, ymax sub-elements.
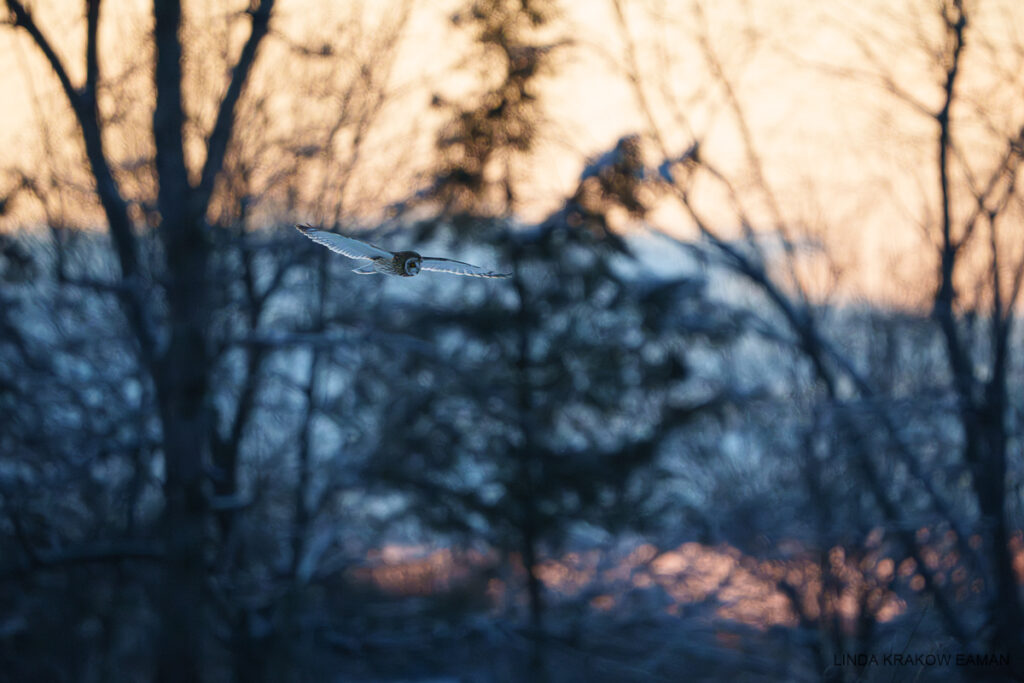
<box><xmin>6</xmin><ymin>0</ymin><xmax>273</xmax><ymax>681</ymax></box>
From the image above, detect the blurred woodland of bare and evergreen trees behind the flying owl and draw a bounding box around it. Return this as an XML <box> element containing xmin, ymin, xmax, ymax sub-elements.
<box><xmin>0</xmin><ymin>0</ymin><xmax>1024</xmax><ymax>681</ymax></box>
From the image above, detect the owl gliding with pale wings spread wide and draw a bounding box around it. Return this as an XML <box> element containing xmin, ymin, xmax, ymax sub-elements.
<box><xmin>295</xmin><ymin>225</ymin><xmax>512</xmax><ymax>278</ymax></box>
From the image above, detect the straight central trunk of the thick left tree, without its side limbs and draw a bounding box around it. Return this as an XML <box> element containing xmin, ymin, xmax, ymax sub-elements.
<box><xmin>153</xmin><ymin>0</ymin><xmax>210</xmax><ymax>683</ymax></box>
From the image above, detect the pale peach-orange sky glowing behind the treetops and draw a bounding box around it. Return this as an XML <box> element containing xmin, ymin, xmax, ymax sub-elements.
<box><xmin>0</xmin><ymin>0</ymin><xmax>1024</xmax><ymax>304</ymax></box>
